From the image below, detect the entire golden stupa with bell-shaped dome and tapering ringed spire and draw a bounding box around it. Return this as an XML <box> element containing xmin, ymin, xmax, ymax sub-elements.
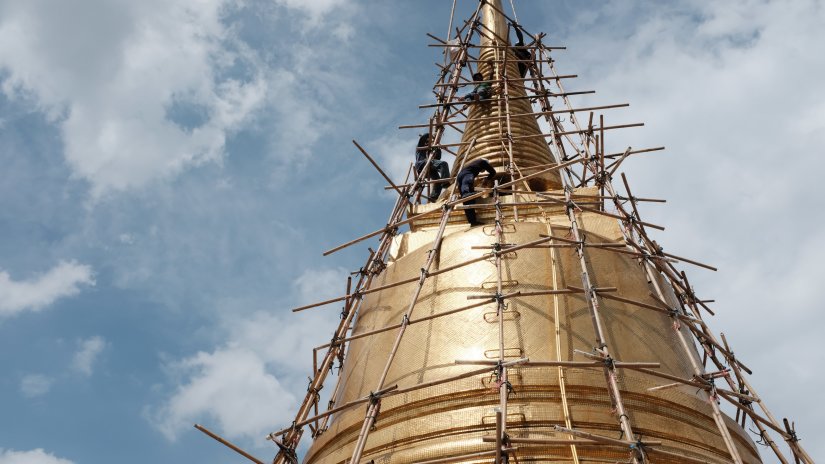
<box><xmin>256</xmin><ymin>0</ymin><xmax>804</xmax><ymax>464</ymax></box>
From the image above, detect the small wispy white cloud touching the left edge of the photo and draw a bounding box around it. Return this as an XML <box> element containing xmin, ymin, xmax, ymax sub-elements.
<box><xmin>0</xmin><ymin>261</ymin><xmax>95</xmax><ymax>317</ymax></box>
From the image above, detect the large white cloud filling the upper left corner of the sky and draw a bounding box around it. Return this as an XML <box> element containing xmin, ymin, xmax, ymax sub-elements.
<box><xmin>0</xmin><ymin>0</ymin><xmax>267</xmax><ymax>195</ymax></box>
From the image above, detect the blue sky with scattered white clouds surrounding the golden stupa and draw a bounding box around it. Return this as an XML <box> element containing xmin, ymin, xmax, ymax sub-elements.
<box><xmin>0</xmin><ymin>0</ymin><xmax>825</xmax><ymax>464</ymax></box>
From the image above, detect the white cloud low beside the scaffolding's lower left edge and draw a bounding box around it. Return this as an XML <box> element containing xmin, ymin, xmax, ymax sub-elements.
<box><xmin>147</xmin><ymin>269</ymin><xmax>346</xmax><ymax>440</ymax></box>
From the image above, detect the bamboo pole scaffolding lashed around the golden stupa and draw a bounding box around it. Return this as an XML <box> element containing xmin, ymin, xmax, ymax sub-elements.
<box><xmin>268</xmin><ymin>0</ymin><xmax>813</xmax><ymax>464</ymax></box>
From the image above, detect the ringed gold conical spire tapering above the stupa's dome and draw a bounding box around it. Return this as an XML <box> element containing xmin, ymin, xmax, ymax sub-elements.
<box><xmin>454</xmin><ymin>0</ymin><xmax>561</xmax><ymax>190</ymax></box>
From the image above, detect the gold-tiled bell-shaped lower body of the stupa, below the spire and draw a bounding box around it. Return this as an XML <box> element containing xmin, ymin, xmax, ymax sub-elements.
<box><xmin>307</xmin><ymin>214</ymin><xmax>759</xmax><ymax>463</ymax></box>
